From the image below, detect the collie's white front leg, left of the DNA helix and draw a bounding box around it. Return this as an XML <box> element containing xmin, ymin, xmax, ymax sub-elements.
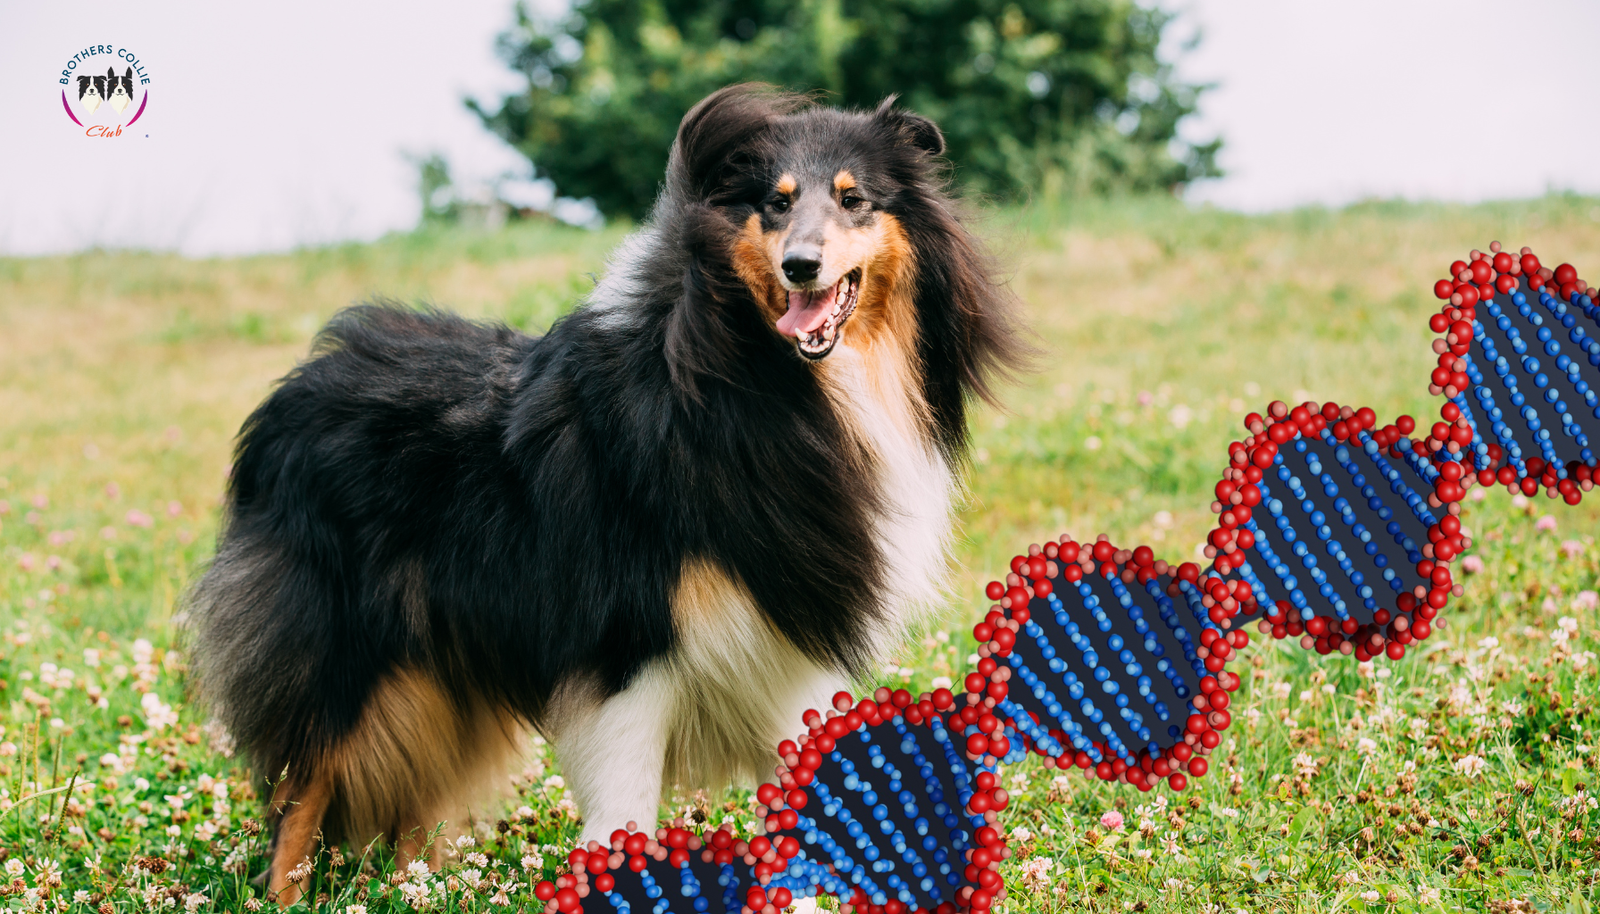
<box><xmin>554</xmin><ymin>667</ymin><xmax>677</xmax><ymax>844</ymax></box>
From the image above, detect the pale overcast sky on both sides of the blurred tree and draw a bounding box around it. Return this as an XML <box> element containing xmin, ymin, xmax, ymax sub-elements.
<box><xmin>0</xmin><ymin>0</ymin><xmax>1600</xmax><ymax>255</ymax></box>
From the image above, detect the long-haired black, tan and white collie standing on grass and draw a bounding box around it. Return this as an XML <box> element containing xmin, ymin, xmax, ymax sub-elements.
<box><xmin>190</xmin><ymin>85</ymin><xmax>1026</xmax><ymax>901</ymax></box>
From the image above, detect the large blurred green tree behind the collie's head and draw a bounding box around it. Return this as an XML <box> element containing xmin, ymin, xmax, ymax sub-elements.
<box><xmin>467</xmin><ymin>0</ymin><xmax>1221</xmax><ymax>218</ymax></box>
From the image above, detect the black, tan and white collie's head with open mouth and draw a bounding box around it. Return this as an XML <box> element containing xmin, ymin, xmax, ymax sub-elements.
<box><xmin>653</xmin><ymin>85</ymin><xmax>1022</xmax><ymax>448</ymax></box>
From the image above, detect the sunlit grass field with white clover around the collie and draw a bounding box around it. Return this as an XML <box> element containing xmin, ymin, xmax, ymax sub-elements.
<box><xmin>0</xmin><ymin>197</ymin><xmax>1600</xmax><ymax>914</ymax></box>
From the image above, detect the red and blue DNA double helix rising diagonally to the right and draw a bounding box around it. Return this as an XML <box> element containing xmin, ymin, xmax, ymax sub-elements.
<box><xmin>536</xmin><ymin>242</ymin><xmax>1600</xmax><ymax>914</ymax></box>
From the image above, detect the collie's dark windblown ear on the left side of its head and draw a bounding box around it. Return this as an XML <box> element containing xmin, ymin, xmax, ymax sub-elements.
<box><xmin>667</xmin><ymin>83</ymin><xmax>810</xmax><ymax>200</ymax></box>
